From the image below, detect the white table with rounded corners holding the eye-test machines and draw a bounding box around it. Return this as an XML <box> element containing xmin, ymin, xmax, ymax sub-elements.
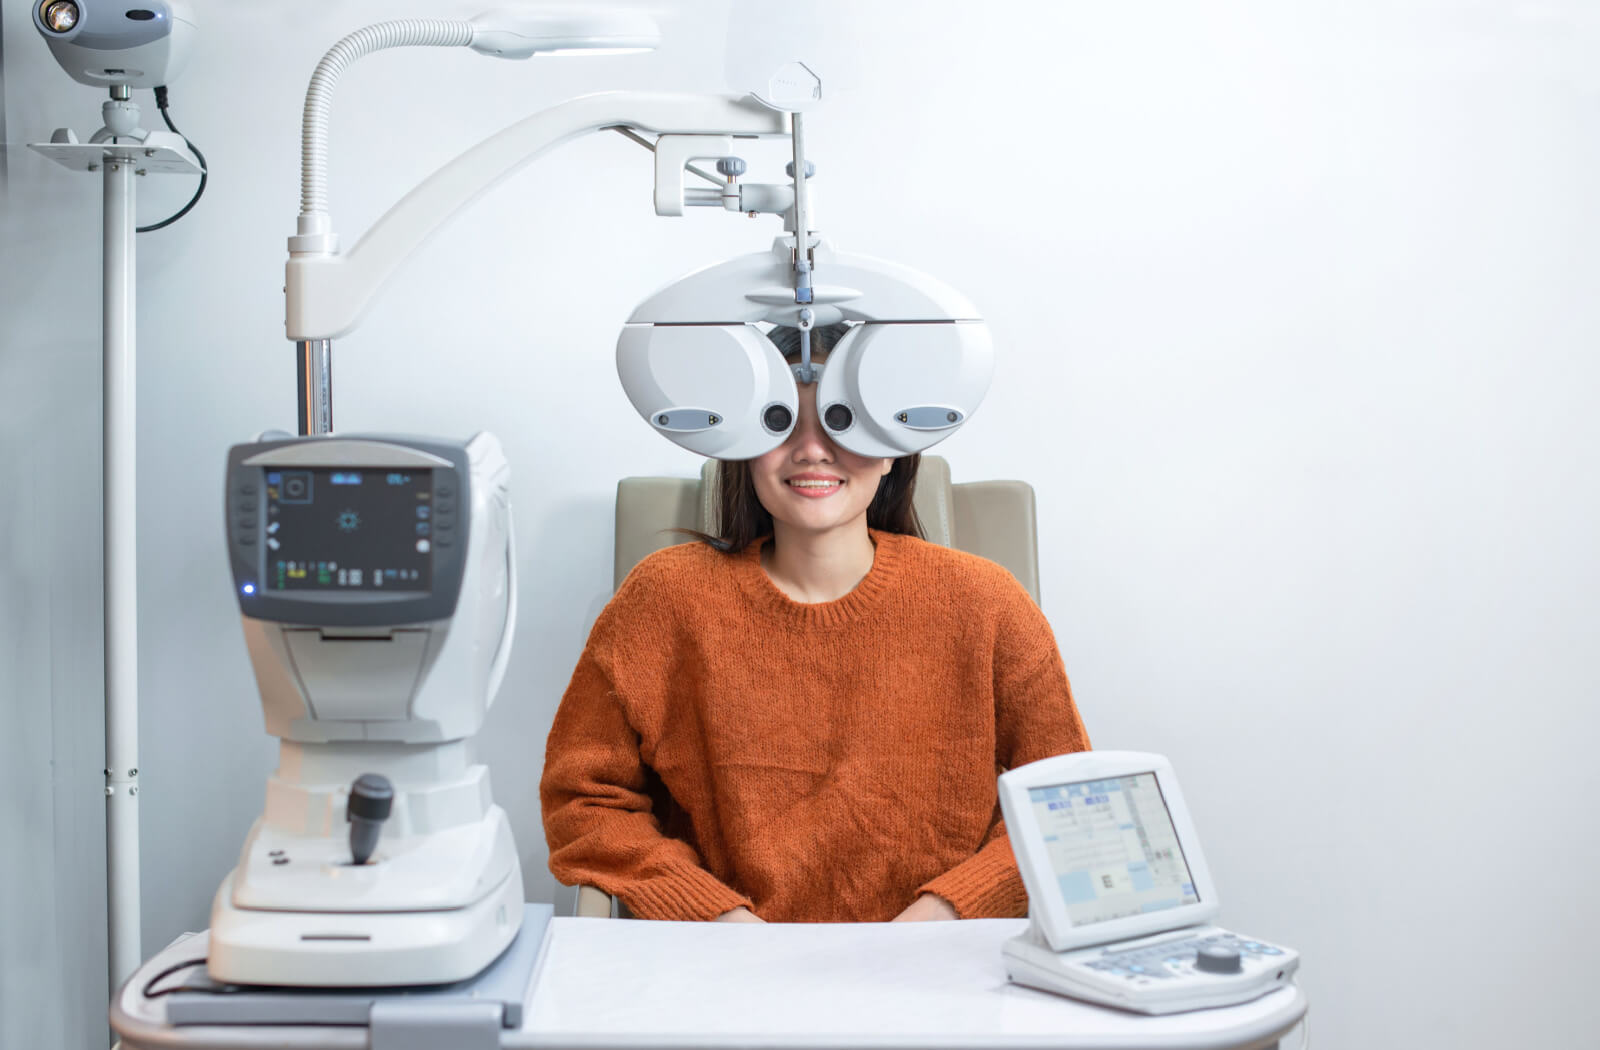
<box><xmin>112</xmin><ymin>919</ymin><xmax>1306</xmax><ymax>1050</ymax></box>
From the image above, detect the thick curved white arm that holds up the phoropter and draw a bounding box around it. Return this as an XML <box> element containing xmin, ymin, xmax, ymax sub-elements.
<box><xmin>285</xmin><ymin>91</ymin><xmax>789</xmax><ymax>341</ymax></box>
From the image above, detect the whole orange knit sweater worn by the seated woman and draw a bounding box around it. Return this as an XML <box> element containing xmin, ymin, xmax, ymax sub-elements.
<box><xmin>539</xmin><ymin>531</ymin><xmax>1090</xmax><ymax>922</ymax></box>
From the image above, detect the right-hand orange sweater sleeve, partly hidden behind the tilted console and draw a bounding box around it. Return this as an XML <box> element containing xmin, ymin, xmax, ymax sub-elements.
<box><xmin>918</xmin><ymin>586</ymin><xmax>1090</xmax><ymax>919</ymax></box>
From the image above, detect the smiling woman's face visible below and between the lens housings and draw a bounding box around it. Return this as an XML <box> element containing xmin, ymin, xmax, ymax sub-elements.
<box><xmin>750</xmin><ymin>364</ymin><xmax>894</xmax><ymax>533</ymax></box>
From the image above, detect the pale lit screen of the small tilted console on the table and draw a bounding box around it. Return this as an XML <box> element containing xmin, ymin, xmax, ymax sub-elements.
<box><xmin>1027</xmin><ymin>773</ymin><xmax>1200</xmax><ymax>927</ymax></box>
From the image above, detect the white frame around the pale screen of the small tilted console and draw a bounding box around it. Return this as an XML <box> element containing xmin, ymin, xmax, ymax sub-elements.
<box><xmin>1000</xmin><ymin>751</ymin><xmax>1221</xmax><ymax>951</ymax></box>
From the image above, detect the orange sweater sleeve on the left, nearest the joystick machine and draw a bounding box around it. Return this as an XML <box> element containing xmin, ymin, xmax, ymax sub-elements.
<box><xmin>539</xmin><ymin>617</ymin><xmax>750</xmax><ymax>920</ymax></box>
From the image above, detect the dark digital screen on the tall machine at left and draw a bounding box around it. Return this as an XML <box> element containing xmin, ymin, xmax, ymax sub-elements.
<box><xmin>262</xmin><ymin>467</ymin><xmax>434</xmax><ymax>594</ymax></box>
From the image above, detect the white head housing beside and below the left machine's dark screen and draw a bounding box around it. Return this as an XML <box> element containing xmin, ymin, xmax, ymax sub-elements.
<box><xmin>242</xmin><ymin>434</ymin><xmax>517</xmax><ymax>743</ymax></box>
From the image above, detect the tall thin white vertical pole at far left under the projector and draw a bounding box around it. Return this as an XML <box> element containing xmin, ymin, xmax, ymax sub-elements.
<box><xmin>101</xmin><ymin>153</ymin><xmax>142</xmax><ymax>992</ymax></box>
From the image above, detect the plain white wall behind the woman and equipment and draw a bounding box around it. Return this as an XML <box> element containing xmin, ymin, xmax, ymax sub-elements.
<box><xmin>0</xmin><ymin>0</ymin><xmax>1600</xmax><ymax>1050</ymax></box>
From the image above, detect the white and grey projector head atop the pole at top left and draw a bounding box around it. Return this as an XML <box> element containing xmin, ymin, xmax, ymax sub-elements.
<box><xmin>34</xmin><ymin>0</ymin><xmax>195</xmax><ymax>88</ymax></box>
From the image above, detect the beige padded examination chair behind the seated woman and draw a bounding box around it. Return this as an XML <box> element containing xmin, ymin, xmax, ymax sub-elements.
<box><xmin>574</xmin><ymin>455</ymin><xmax>1038</xmax><ymax>919</ymax></box>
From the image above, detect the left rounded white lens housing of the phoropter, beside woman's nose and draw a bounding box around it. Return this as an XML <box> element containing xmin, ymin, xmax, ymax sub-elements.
<box><xmin>616</xmin><ymin>325</ymin><xmax>800</xmax><ymax>459</ymax></box>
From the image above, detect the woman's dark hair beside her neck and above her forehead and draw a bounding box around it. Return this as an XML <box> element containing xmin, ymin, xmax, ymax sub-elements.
<box><xmin>677</xmin><ymin>325</ymin><xmax>926</xmax><ymax>554</ymax></box>
